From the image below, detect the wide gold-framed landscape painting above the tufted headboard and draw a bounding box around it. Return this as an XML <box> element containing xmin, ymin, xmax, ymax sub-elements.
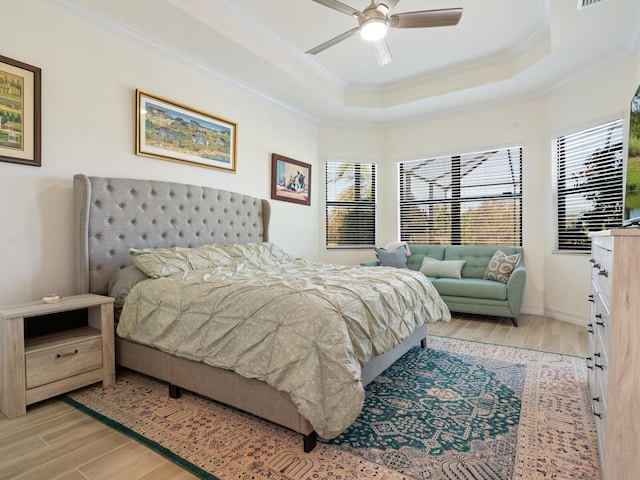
<box><xmin>136</xmin><ymin>90</ymin><xmax>238</xmax><ymax>173</ymax></box>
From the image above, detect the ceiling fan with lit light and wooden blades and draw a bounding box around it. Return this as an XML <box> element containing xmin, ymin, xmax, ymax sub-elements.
<box><xmin>307</xmin><ymin>0</ymin><xmax>462</xmax><ymax>67</ymax></box>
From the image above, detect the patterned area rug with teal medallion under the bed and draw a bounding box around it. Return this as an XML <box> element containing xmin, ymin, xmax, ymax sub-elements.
<box><xmin>66</xmin><ymin>336</ymin><xmax>600</xmax><ymax>480</ymax></box>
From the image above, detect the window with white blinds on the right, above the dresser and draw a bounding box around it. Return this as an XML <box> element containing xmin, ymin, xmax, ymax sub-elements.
<box><xmin>554</xmin><ymin>120</ymin><xmax>623</xmax><ymax>251</ymax></box>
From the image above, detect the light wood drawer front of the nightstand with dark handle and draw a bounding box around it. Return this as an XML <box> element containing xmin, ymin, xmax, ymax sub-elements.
<box><xmin>25</xmin><ymin>336</ymin><xmax>102</xmax><ymax>389</ymax></box>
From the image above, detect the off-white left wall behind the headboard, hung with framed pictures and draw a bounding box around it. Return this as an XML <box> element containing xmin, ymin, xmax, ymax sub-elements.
<box><xmin>0</xmin><ymin>0</ymin><xmax>322</xmax><ymax>304</ymax></box>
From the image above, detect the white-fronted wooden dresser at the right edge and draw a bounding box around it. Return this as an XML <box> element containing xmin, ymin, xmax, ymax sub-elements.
<box><xmin>587</xmin><ymin>228</ymin><xmax>640</xmax><ymax>480</ymax></box>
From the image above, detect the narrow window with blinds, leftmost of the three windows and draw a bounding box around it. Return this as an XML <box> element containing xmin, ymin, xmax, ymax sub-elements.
<box><xmin>326</xmin><ymin>162</ymin><xmax>376</xmax><ymax>248</ymax></box>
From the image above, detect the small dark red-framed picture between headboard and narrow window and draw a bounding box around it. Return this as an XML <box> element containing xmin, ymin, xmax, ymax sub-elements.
<box><xmin>271</xmin><ymin>153</ymin><xmax>311</xmax><ymax>205</ymax></box>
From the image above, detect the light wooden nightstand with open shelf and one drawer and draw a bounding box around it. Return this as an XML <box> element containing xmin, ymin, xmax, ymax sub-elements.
<box><xmin>0</xmin><ymin>294</ymin><xmax>116</xmax><ymax>418</ymax></box>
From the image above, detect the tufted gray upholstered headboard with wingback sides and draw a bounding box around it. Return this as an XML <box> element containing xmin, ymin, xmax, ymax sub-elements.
<box><xmin>73</xmin><ymin>174</ymin><xmax>271</xmax><ymax>295</ymax></box>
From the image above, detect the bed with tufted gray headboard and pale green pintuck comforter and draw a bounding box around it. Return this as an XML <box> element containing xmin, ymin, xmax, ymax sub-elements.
<box><xmin>73</xmin><ymin>174</ymin><xmax>450</xmax><ymax>452</ymax></box>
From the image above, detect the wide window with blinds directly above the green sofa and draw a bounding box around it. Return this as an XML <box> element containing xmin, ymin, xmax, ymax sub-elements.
<box><xmin>400</xmin><ymin>147</ymin><xmax>522</xmax><ymax>245</ymax></box>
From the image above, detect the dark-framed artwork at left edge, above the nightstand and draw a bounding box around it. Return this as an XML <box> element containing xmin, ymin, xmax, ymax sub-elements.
<box><xmin>0</xmin><ymin>55</ymin><xmax>41</xmax><ymax>167</ymax></box>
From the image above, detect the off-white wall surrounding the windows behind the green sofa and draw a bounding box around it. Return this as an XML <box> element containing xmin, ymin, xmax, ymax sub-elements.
<box><xmin>320</xmin><ymin>55</ymin><xmax>640</xmax><ymax>323</ymax></box>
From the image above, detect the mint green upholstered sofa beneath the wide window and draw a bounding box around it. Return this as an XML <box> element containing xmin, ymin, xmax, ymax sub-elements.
<box><xmin>361</xmin><ymin>245</ymin><xmax>526</xmax><ymax>327</ymax></box>
